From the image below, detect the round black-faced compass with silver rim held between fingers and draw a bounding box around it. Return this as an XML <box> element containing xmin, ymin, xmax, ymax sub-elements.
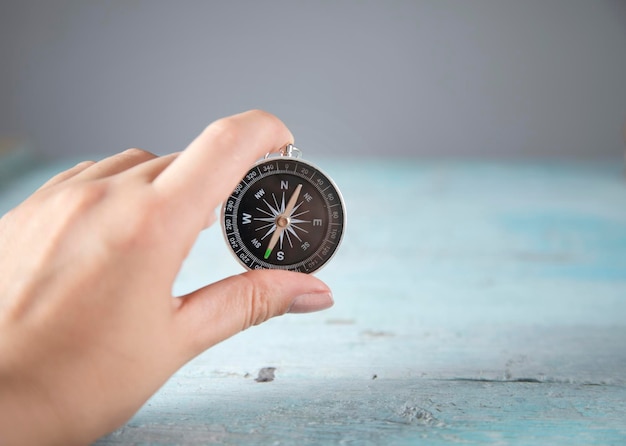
<box><xmin>222</xmin><ymin>144</ymin><xmax>346</xmax><ymax>273</ymax></box>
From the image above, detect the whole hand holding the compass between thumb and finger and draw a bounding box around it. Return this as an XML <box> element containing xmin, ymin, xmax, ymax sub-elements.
<box><xmin>0</xmin><ymin>111</ymin><xmax>332</xmax><ymax>445</ymax></box>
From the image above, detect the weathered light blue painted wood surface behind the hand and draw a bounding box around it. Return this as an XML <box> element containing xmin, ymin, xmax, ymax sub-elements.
<box><xmin>0</xmin><ymin>159</ymin><xmax>626</xmax><ymax>445</ymax></box>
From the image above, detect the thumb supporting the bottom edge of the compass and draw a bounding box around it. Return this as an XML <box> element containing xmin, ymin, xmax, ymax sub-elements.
<box><xmin>175</xmin><ymin>270</ymin><xmax>333</xmax><ymax>359</ymax></box>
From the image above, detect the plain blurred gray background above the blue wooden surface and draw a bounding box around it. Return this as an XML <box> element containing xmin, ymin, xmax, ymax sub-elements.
<box><xmin>0</xmin><ymin>0</ymin><xmax>626</xmax><ymax>158</ymax></box>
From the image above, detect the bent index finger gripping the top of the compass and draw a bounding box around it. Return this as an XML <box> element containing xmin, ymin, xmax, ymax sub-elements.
<box><xmin>153</xmin><ymin>110</ymin><xmax>293</xmax><ymax>231</ymax></box>
